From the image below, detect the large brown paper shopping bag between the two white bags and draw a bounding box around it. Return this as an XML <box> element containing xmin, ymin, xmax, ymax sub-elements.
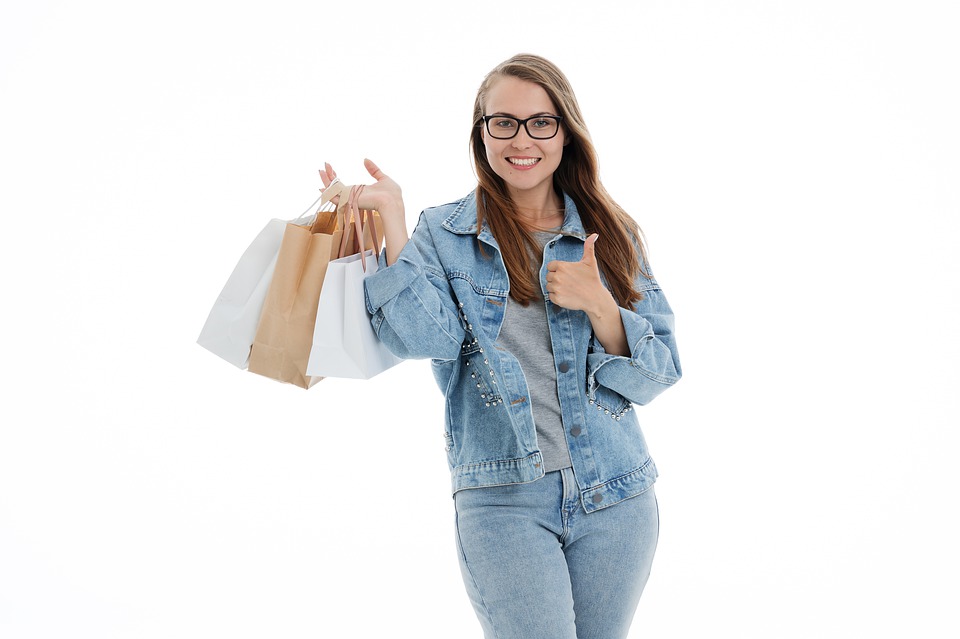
<box><xmin>248</xmin><ymin>182</ymin><xmax>346</xmax><ymax>388</ymax></box>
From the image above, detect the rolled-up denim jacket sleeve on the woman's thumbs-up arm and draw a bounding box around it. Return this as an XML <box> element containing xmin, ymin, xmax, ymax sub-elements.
<box><xmin>587</xmin><ymin>264</ymin><xmax>682</xmax><ymax>405</ymax></box>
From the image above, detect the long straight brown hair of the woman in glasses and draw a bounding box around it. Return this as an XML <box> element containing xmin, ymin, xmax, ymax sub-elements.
<box><xmin>470</xmin><ymin>53</ymin><xmax>650</xmax><ymax>308</ymax></box>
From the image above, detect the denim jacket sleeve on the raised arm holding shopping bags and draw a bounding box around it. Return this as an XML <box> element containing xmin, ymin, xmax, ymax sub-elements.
<box><xmin>364</xmin><ymin>213</ymin><xmax>465</xmax><ymax>360</ymax></box>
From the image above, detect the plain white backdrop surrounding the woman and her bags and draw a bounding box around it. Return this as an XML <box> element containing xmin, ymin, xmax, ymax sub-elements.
<box><xmin>0</xmin><ymin>0</ymin><xmax>960</xmax><ymax>639</ymax></box>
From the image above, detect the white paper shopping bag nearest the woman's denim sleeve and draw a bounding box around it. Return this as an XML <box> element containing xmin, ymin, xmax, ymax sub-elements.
<box><xmin>307</xmin><ymin>251</ymin><xmax>403</xmax><ymax>379</ymax></box>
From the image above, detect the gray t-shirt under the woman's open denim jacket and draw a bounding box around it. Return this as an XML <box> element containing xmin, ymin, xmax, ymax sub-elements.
<box><xmin>497</xmin><ymin>232</ymin><xmax>571</xmax><ymax>473</ymax></box>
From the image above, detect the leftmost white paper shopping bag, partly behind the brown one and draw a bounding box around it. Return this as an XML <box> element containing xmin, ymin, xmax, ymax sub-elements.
<box><xmin>197</xmin><ymin>198</ymin><xmax>320</xmax><ymax>368</ymax></box>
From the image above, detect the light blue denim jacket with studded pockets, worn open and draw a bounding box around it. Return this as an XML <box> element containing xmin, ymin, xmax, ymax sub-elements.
<box><xmin>365</xmin><ymin>193</ymin><xmax>680</xmax><ymax>512</ymax></box>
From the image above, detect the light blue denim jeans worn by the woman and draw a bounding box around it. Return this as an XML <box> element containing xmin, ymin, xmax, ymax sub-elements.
<box><xmin>454</xmin><ymin>468</ymin><xmax>660</xmax><ymax>639</ymax></box>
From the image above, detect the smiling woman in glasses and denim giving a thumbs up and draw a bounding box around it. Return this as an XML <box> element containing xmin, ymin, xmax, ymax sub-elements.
<box><xmin>322</xmin><ymin>55</ymin><xmax>680</xmax><ymax>639</ymax></box>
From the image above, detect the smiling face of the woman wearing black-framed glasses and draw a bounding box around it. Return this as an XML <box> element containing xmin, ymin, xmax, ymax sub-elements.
<box><xmin>482</xmin><ymin>76</ymin><xmax>565</xmax><ymax>198</ymax></box>
